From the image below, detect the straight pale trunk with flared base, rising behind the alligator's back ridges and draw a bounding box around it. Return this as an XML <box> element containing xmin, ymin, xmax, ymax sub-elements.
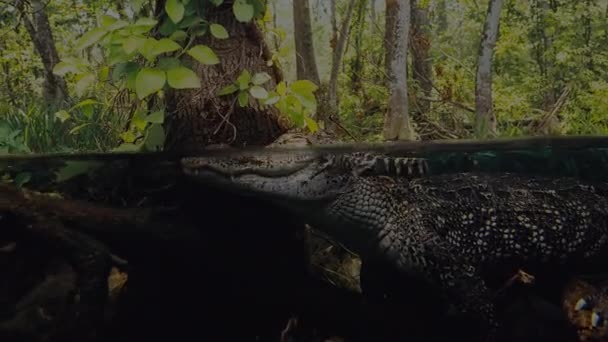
<box><xmin>383</xmin><ymin>0</ymin><xmax>415</xmax><ymax>140</ymax></box>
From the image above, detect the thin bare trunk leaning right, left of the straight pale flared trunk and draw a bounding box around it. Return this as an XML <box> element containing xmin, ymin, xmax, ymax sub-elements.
<box><xmin>323</xmin><ymin>0</ymin><xmax>357</xmax><ymax>131</ymax></box>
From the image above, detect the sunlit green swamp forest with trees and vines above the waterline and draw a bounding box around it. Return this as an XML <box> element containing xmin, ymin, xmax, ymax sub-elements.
<box><xmin>0</xmin><ymin>0</ymin><xmax>608</xmax><ymax>153</ymax></box>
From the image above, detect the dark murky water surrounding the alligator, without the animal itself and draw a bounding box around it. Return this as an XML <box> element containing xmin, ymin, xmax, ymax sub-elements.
<box><xmin>0</xmin><ymin>138</ymin><xmax>608</xmax><ymax>341</ymax></box>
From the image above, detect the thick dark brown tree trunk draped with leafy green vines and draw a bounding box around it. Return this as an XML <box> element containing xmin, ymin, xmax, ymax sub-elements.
<box><xmin>163</xmin><ymin>0</ymin><xmax>290</xmax><ymax>152</ymax></box>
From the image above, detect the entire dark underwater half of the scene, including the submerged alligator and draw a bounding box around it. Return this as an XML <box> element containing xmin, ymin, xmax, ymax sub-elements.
<box><xmin>0</xmin><ymin>137</ymin><xmax>608</xmax><ymax>342</ymax></box>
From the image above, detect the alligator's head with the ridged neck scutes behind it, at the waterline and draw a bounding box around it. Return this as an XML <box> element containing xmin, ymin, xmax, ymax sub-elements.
<box><xmin>182</xmin><ymin>150</ymin><xmax>428</xmax><ymax>201</ymax></box>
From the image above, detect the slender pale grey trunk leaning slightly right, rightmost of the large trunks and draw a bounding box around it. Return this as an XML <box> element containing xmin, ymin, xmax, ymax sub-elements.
<box><xmin>475</xmin><ymin>0</ymin><xmax>502</xmax><ymax>138</ymax></box>
